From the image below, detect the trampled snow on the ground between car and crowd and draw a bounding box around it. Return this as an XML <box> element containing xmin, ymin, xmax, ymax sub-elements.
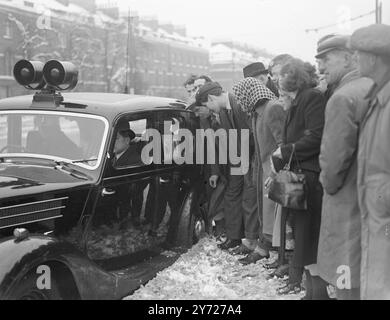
<box><xmin>125</xmin><ymin>238</ymin><xmax>304</xmax><ymax>300</ymax></box>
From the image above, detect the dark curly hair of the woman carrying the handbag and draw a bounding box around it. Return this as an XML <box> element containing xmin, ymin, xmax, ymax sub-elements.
<box><xmin>280</xmin><ymin>58</ymin><xmax>318</xmax><ymax>92</ymax></box>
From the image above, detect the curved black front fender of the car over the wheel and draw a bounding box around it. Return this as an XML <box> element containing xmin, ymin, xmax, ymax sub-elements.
<box><xmin>0</xmin><ymin>236</ymin><xmax>129</xmax><ymax>300</ymax></box>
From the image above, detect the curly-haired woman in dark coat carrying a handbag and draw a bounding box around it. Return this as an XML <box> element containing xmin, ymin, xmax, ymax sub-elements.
<box><xmin>273</xmin><ymin>59</ymin><xmax>327</xmax><ymax>298</ymax></box>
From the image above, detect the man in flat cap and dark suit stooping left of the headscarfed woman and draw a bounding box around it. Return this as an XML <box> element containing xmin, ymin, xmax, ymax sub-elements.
<box><xmin>196</xmin><ymin>82</ymin><xmax>259</xmax><ymax>254</ymax></box>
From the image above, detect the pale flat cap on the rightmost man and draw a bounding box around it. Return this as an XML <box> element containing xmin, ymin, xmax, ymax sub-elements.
<box><xmin>350</xmin><ymin>24</ymin><xmax>390</xmax><ymax>56</ymax></box>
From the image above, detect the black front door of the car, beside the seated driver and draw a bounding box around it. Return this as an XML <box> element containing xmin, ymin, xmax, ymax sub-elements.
<box><xmin>86</xmin><ymin>112</ymin><xmax>160</xmax><ymax>262</ymax></box>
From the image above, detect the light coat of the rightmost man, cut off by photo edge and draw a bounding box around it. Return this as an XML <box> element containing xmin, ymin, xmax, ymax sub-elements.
<box><xmin>358</xmin><ymin>76</ymin><xmax>390</xmax><ymax>299</ymax></box>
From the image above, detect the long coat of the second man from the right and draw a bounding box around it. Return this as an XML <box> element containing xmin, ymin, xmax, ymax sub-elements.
<box><xmin>317</xmin><ymin>71</ymin><xmax>372</xmax><ymax>288</ymax></box>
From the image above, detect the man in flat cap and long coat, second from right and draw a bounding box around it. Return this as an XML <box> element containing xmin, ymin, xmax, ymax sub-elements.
<box><xmin>316</xmin><ymin>35</ymin><xmax>372</xmax><ymax>300</ymax></box>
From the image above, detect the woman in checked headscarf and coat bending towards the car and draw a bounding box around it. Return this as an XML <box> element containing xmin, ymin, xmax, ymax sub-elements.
<box><xmin>233</xmin><ymin>77</ymin><xmax>285</xmax><ymax>264</ymax></box>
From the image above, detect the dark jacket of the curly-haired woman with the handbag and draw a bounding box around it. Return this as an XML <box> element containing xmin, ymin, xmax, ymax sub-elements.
<box><xmin>275</xmin><ymin>88</ymin><xmax>326</xmax><ymax>173</ymax></box>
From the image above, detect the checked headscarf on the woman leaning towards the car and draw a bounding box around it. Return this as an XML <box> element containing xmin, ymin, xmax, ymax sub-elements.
<box><xmin>233</xmin><ymin>78</ymin><xmax>277</xmax><ymax>113</ymax></box>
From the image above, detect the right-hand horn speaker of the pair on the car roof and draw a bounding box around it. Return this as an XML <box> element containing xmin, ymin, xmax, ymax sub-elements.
<box><xmin>43</xmin><ymin>60</ymin><xmax>78</xmax><ymax>91</ymax></box>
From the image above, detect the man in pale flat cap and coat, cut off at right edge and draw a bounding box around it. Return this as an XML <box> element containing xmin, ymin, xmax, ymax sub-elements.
<box><xmin>351</xmin><ymin>24</ymin><xmax>390</xmax><ymax>300</ymax></box>
